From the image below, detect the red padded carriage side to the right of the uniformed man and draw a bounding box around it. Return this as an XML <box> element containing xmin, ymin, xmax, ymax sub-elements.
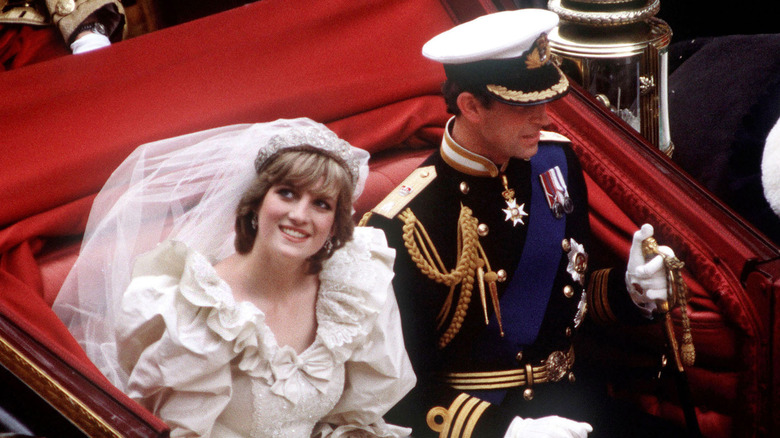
<box><xmin>551</xmin><ymin>93</ymin><xmax>780</xmax><ymax>437</ymax></box>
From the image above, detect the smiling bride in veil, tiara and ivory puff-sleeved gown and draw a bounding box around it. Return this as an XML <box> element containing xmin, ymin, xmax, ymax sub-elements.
<box><xmin>54</xmin><ymin>119</ymin><xmax>415</xmax><ymax>437</ymax></box>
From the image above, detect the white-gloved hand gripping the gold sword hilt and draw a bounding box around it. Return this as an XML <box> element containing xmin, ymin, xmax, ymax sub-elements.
<box><xmin>626</xmin><ymin>224</ymin><xmax>674</xmax><ymax>318</ymax></box>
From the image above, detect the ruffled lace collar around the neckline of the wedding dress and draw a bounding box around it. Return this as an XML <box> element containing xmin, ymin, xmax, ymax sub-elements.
<box><xmin>174</xmin><ymin>228</ymin><xmax>394</xmax><ymax>403</ymax></box>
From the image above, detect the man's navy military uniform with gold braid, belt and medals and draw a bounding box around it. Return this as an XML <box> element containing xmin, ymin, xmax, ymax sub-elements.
<box><xmin>363</xmin><ymin>119</ymin><xmax>639</xmax><ymax>437</ymax></box>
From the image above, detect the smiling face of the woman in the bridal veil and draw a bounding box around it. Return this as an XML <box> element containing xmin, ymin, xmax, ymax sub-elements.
<box><xmin>255</xmin><ymin>184</ymin><xmax>337</xmax><ymax>261</ymax></box>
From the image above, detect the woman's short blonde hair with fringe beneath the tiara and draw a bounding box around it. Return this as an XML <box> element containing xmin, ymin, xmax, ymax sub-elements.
<box><xmin>235</xmin><ymin>145</ymin><xmax>355</xmax><ymax>274</ymax></box>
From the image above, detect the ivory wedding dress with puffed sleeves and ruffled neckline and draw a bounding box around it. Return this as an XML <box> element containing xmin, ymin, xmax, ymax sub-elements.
<box><xmin>117</xmin><ymin>227</ymin><xmax>415</xmax><ymax>437</ymax></box>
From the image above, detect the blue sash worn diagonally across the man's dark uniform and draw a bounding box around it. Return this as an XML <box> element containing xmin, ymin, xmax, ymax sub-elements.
<box><xmin>468</xmin><ymin>145</ymin><xmax>569</xmax><ymax>403</ymax></box>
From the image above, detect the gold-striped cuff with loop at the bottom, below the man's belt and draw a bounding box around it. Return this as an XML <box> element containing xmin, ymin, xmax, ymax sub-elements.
<box><xmin>426</xmin><ymin>394</ymin><xmax>490</xmax><ymax>438</ymax></box>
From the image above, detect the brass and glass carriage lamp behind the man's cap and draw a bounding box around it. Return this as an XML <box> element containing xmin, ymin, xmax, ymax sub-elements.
<box><xmin>548</xmin><ymin>0</ymin><xmax>674</xmax><ymax>156</ymax></box>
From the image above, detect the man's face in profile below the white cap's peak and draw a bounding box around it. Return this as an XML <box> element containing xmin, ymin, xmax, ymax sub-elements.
<box><xmin>472</xmin><ymin>102</ymin><xmax>550</xmax><ymax>165</ymax></box>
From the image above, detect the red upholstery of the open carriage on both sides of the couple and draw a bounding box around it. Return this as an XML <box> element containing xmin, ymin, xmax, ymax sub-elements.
<box><xmin>0</xmin><ymin>0</ymin><xmax>780</xmax><ymax>437</ymax></box>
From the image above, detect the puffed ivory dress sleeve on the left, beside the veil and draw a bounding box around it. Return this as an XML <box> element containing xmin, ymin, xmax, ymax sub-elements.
<box><xmin>117</xmin><ymin>243</ymin><xmax>234</xmax><ymax>437</ymax></box>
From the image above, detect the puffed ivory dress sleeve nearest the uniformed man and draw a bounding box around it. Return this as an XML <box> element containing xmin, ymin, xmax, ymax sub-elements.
<box><xmin>313</xmin><ymin>229</ymin><xmax>416</xmax><ymax>438</ymax></box>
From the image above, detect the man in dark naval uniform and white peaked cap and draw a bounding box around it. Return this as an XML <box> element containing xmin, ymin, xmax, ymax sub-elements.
<box><xmin>361</xmin><ymin>9</ymin><xmax>684</xmax><ymax>437</ymax></box>
